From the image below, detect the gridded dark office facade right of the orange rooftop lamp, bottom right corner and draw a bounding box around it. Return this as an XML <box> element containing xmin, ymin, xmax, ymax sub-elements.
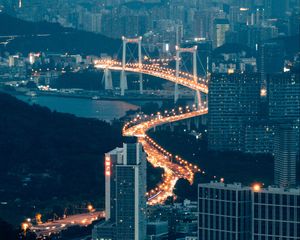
<box><xmin>252</xmin><ymin>187</ymin><xmax>300</xmax><ymax>240</ymax></box>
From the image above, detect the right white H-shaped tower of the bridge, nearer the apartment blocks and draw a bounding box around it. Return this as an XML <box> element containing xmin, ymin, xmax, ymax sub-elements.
<box><xmin>174</xmin><ymin>46</ymin><xmax>201</xmax><ymax>107</ymax></box>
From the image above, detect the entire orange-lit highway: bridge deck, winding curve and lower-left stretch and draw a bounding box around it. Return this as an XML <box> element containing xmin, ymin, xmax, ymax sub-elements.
<box><xmin>22</xmin><ymin>55</ymin><xmax>208</xmax><ymax>236</ymax></box>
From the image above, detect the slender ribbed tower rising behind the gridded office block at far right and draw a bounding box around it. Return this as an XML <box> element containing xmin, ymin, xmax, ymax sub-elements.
<box><xmin>274</xmin><ymin>124</ymin><xmax>297</xmax><ymax>187</ymax></box>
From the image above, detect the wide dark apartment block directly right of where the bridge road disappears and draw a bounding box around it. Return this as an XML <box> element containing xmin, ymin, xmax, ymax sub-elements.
<box><xmin>208</xmin><ymin>74</ymin><xmax>260</xmax><ymax>151</ymax></box>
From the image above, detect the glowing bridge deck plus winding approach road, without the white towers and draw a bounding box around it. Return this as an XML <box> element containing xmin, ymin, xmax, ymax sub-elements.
<box><xmin>95</xmin><ymin>59</ymin><xmax>208</xmax><ymax>205</ymax></box>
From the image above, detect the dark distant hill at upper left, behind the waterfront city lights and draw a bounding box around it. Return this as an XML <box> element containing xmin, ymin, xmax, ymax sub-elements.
<box><xmin>0</xmin><ymin>13</ymin><xmax>121</xmax><ymax>55</ymax></box>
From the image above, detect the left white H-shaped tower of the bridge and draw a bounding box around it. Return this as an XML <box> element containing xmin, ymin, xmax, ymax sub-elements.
<box><xmin>120</xmin><ymin>36</ymin><xmax>143</xmax><ymax>96</ymax></box>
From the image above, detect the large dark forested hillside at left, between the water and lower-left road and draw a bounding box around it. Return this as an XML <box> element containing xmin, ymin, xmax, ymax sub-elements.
<box><xmin>0</xmin><ymin>93</ymin><xmax>122</xmax><ymax>202</ymax></box>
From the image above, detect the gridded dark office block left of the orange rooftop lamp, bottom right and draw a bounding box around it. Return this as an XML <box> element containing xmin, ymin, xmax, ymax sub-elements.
<box><xmin>198</xmin><ymin>182</ymin><xmax>251</xmax><ymax>240</ymax></box>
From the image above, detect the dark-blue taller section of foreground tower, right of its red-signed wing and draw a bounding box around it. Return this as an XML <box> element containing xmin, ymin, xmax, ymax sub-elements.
<box><xmin>116</xmin><ymin>143</ymin><xmax>146</xmax><ymax>240</ymax></box>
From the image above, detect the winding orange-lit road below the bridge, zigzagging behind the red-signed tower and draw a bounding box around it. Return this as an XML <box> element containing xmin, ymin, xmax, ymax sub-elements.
<box><xmin>123</xmin><ymin>107</ymin><xmax>208</xmax><ymax>205</ymax></box>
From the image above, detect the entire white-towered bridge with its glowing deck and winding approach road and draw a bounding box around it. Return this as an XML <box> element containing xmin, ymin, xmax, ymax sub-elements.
<box><xmin>95</xmin><ymin>37</ymin><xmax>208</xmax><ymax>205</ymax></box>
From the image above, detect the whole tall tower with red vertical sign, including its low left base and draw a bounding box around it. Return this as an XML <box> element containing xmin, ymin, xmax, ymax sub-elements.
<box><xmin>93</xmin><ymin>138</ymin><xmax>146</xmax><ymax>240</ymax></box>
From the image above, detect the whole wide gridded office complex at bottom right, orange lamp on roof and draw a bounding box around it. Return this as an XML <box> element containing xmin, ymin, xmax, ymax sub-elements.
<box><xmin>198</xmin><ymin>182</ymin><xmax>300</xmax><ymax>240</ymax></box>
